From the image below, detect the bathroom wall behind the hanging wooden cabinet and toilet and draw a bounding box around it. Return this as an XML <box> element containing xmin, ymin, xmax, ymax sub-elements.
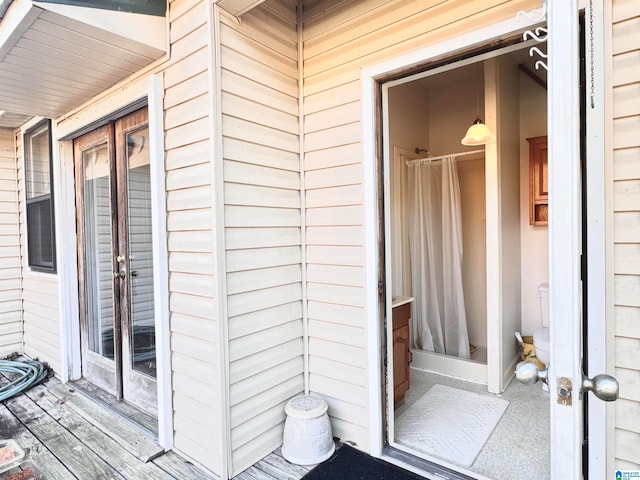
<box><xmin>520</xmin><ymin>73</ymin><xmax>549</xmax><ymax>335</ymax></box>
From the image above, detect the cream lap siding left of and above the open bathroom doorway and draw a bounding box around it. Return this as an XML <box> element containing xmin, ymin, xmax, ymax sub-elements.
<box><xmin>303</xmin><ymin>0</ymin><xmax>539</xmax><ymax>450</ymax></box>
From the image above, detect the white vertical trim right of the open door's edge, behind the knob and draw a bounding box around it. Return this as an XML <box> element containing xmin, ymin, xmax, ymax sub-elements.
<box><xmin>585</xmin><ymin>0</ymin><xmax>615</xmax><ymax>478</ymax></box>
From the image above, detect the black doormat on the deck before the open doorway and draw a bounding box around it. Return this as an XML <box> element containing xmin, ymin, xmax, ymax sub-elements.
<box><xmin>302</xmin><ymin>445</ymin><xmax>424</xmax><ymax>480</ymax></box>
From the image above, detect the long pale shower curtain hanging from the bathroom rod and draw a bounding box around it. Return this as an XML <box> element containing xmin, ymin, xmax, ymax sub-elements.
<box><xmin>408</xmin><ymin>156</ymin><xmax>469</xmax><ymax>358</ymax></box>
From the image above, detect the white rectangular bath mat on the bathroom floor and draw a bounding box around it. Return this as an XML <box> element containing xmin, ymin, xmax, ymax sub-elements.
<box><xmin>395</xmin><ymin>385</ymin><xmax>509</xmax><ymax>467</ymax></box>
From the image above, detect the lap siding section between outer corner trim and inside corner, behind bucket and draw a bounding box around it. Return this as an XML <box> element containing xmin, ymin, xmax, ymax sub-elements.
<box><xmin>220</xmin><ymin>0</ymin><xmax>304</xmax><ymax>474</ymax></box>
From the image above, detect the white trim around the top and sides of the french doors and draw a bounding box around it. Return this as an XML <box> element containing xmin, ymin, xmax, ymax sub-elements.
<box><xmin>52</xmin><ymin>75</ymin><xmax>173</xmax><ymax>450</ymax></box>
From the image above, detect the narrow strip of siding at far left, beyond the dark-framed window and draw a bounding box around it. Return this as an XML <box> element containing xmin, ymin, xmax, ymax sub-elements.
<box><xmin>0</xmin><ymin>129</ymin><xmax>22</xmax><ymax>356</ymax></box>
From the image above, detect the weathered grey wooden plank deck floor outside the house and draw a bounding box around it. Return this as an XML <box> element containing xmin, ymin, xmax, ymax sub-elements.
<box><xmin>0</xmin><ymin>379</ymin><xmax>310</xmax><ymax>480</ymax></box>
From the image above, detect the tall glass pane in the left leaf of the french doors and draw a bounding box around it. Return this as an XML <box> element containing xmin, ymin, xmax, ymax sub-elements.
<box><xmin>82</xmin><ymin>144</ymin><xmax>114</xmax><ymax>358</ymax></box>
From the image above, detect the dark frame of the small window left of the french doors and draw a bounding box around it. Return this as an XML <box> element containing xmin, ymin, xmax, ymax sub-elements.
<box><xmin>22</xmin><ymin>119</ymin><xmax>57</xmax><ymax>274</ymax></box>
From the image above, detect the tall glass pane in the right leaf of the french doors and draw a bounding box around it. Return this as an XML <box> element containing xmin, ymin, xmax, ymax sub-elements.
<box><xmin>127</xmin><ymin>128</ymin><xmax>156</xmax><ymax>377</ymax></box>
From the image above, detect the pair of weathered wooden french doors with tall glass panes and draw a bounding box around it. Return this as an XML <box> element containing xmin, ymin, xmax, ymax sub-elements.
<box><xmin>74</xmin><ymin>108</ymin><xmax>157</xmax><ymax>415</ymax></box>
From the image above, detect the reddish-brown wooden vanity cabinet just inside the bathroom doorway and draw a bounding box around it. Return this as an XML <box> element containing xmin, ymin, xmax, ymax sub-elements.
<box><xmin>392</xmin><ymin>303</ymin><xmax>411</xmax><ymax>408</ymax></box>
